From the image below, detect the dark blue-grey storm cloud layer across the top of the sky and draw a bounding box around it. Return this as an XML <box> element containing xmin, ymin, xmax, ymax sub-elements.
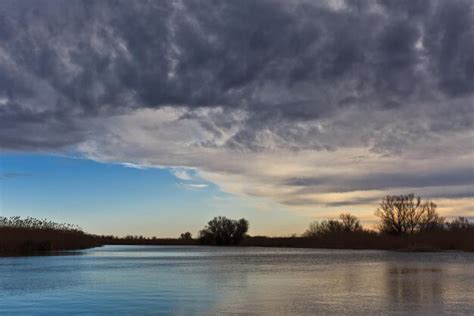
<box><xmin>0</xmin><ymin>0</ymin><xmax>474</xmax><ymax>151</ymax></box>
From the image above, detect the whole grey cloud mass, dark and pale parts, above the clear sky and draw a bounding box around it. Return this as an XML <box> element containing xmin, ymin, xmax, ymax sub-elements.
<box><xmin>0</xmin><ymin>0</ymin><xmax>474</xmax><ymax>217</ymax></box>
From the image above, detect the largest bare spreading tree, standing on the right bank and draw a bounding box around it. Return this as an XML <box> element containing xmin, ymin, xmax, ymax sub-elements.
<box><xmin>375</xmin><ymin>194</ymin><xmax>444</xmax><ymax>235</ymax></box>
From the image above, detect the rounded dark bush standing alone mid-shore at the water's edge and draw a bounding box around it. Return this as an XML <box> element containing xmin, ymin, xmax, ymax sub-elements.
<box><xmin>199</xmin><ymin>216</ymin><xmax>249</xmax><ymax>245</ymax></box>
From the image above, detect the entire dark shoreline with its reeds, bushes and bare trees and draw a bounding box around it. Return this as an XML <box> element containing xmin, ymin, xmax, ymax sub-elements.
<box><xmin>0</xmin><ymin>194</ymin><xmax>474</xmax><ymax>256</ymax></box>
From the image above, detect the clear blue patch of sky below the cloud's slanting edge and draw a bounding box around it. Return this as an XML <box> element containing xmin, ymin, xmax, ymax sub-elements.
<box><xmin>0</xmin><ymin>154</ymin><xmax>305</xmax><ymax>237</ymax></box>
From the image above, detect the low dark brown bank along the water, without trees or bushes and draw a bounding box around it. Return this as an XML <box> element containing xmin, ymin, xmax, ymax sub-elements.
<box><xmin>0</xmin><ymin>230</ymin><xmax>474</xmax><ymax>257</ymax></box>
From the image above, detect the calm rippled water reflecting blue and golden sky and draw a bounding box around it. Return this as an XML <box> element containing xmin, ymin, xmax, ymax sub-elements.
<box><xmin>0</xmin><ymin>246</ymin><xmax>474</xmax><ymax>315</ymax></box>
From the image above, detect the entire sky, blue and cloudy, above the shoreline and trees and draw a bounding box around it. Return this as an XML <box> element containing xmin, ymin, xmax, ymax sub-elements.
<box><xmin>0</xmin><ymin>0</ymin><xmax>474</xmax><ymax>237</ymax></box>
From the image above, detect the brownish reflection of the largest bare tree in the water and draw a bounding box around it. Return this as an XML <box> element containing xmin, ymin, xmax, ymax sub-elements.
<box><xmin>386</xmin><ymin>265</ymin><xmax>444</xmax><ymax>314</ymax></box>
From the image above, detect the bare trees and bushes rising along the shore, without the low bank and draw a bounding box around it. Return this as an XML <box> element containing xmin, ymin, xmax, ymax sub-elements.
<box><xmin>184</xmin><ymin>194</ymin><xmax>474</xmax><ymax>245</ymax></box>
